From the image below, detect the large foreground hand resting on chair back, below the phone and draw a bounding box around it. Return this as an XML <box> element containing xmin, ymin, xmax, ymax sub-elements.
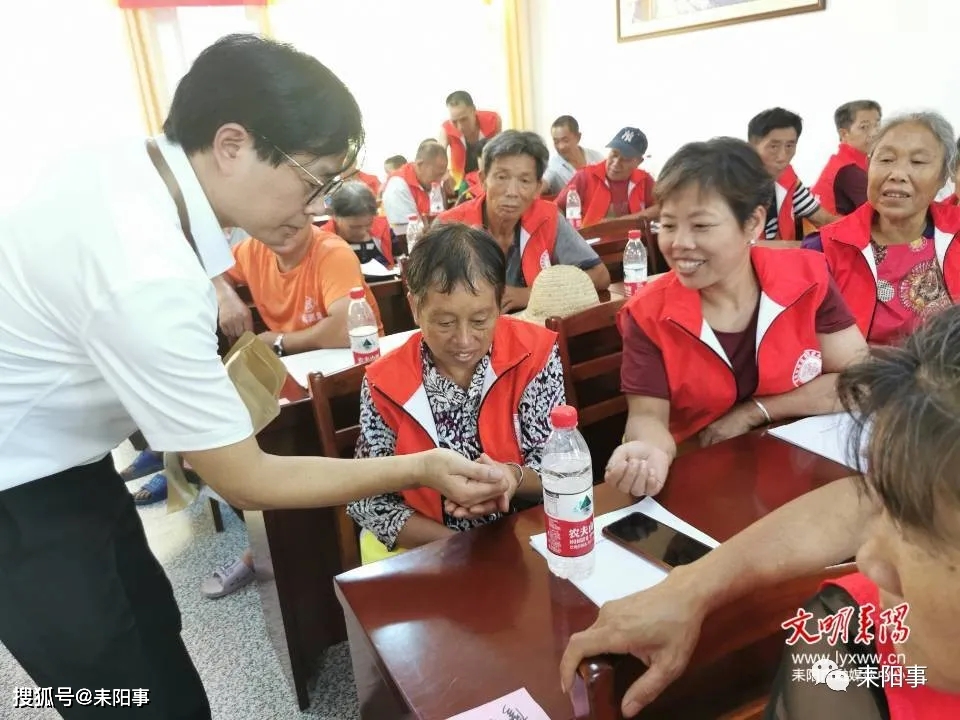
<box><xmin>560</xmin><ymin>574</ymin><xmax>706</xmax><ymax>717</ymax></box>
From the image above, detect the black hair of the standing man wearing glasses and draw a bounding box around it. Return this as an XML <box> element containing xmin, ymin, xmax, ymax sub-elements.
<box><xmin>163</xmin><ymin>34</ymin><xmax>363</xmax><ymax>166</ymax></box>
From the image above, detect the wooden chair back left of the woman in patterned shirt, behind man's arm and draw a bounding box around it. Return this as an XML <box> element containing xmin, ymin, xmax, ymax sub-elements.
<box><xmin>309</xmin><ymin>365</ymin><xmax>367</xmax><ymax>571</ymax></box>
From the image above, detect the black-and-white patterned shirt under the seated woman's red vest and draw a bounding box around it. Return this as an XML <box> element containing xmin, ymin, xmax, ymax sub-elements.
<box><xmin>347</xmin><ymin>343</ymin><xmax>566</xmax><ymax>550</ymax></box>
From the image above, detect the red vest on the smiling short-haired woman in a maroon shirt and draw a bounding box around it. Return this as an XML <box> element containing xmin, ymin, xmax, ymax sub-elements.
<box><xmin>618</xmin><ymin>246</ymin><xmax>830</xmax><ymax>444</ymax></box>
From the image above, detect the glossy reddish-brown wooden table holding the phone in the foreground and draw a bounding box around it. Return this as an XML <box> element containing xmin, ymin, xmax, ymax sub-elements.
<box><xmin>336</xmin><ymin>433</ymin><xmax>850</xmax><ymax>720</ymax></box>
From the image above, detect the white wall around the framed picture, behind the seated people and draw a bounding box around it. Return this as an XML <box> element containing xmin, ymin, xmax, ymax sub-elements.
<box><xmin>528</xmin><ymin>0</ymin><xmax>960</xmax><ymax>184</ymax></box>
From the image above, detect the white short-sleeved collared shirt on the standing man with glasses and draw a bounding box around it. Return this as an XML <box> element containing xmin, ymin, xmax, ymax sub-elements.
<box><xmin>0</xmin><ymin>138</ymin><xmax>252</xmax><ymax>490</ymax></box>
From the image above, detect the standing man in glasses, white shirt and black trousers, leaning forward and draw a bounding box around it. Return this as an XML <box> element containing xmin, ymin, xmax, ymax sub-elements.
<box><xmin>0</xmin><ymin>35</ymin><xmax>506</xmax><ymax>720</ymax></box>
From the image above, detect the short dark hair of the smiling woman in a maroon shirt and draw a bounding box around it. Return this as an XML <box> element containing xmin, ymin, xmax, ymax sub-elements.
<box><xmin>654</xmin><ymin>137</ymin><xmax>773</xmax><ymax>228</ymax></box>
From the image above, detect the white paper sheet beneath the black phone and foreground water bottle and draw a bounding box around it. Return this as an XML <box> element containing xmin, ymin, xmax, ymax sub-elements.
<box><xmin>530</xmin><ymin>497</ymin><xmax>720</xmax><ymax>606</ymax></box>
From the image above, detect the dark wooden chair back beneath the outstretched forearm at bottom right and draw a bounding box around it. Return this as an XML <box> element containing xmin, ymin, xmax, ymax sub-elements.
<box><xmin>579</xmin><ymin>563</ymin><xmax>856</xmax><ymax>720</ymax></box>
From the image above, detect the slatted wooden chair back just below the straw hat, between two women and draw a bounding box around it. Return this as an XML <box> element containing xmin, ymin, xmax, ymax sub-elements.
<box><xmin>545</xmin><ymin>298</ymin><xmax>627</xmax><ymax>481</ymax></box>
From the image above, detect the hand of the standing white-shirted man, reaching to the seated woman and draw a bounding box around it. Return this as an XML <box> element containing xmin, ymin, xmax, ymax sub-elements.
<box><xmin>420</xmin><ymin>448</ymin><xmax>515</xmax><ymax>508</ymax></box>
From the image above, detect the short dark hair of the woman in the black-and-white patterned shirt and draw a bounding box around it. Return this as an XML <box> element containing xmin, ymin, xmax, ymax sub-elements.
<box><xmin>404</xmin><ymin>223</ymin><xmax>507</xmax><ymax>307</ymax></box>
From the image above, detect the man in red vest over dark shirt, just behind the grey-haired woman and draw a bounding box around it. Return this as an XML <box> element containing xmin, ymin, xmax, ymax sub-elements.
<box><xmin>813</xmin><ymin>100</ymin><xmax>881</xmax><ymax>215</ymax></box>
